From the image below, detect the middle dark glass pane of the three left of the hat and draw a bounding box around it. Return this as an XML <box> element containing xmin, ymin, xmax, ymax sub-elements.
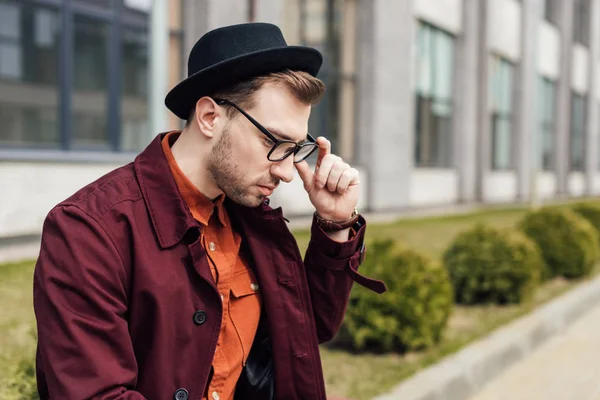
<box><xmin>72</xmin><ymin>15</ymin><xmax>109</xmax><ymax>147</ymax></box>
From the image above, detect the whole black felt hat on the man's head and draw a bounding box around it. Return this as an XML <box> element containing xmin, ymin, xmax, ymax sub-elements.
<box><xmin>165</xmin><ymin>23</ymin><xmax>323</xmax><ymax>119</ymax></box>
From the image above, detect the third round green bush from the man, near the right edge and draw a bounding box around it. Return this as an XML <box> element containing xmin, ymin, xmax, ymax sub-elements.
<box><xmin>519</xmin><ymin>208</ymin><xmax>599</xmax><ymax>278</ymax></box>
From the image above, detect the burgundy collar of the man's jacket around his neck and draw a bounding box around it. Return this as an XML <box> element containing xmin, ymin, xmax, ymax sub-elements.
<box><xmin>134</xmin><ymin>133</ymin><xmax>283</xmax><ymax>249</ymax></box>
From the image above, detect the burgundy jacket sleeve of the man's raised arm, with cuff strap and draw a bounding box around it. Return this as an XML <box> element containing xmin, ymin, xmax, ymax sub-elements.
<box><xmin>304</xmin><ymin>217</ymin><xmax>386</xmax><ymax>343</ymax></box>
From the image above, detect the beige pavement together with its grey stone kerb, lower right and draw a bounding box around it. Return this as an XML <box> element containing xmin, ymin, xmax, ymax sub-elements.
<box><xmin>376</xmin><ymin>276</ymin><xmax>600</xmax><ymax>400</ymax></box>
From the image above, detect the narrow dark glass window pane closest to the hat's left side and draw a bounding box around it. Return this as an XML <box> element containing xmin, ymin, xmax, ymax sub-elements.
<box><xmin>121</xmin><ymin>29</ymin><xmax>150</xmax><ymax>151</ymax></box>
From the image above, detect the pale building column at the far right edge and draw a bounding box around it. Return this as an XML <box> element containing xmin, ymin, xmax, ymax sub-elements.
<box><xmin>585</xmin><ymin>0</ymin><xmax>600</xmax><ymax>195</ymax></box>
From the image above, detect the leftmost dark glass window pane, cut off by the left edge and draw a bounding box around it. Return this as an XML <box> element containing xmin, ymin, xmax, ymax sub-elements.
<box><xmin>0</xmin><ymin>0</ymin><xmax>60</xmax><ymax>147</ymax></box>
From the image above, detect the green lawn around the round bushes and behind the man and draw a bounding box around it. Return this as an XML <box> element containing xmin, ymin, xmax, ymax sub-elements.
<box><xmin>0</xmin><ymin>203</ymin><xmax>599</xmax><ymax>400</ymax></box>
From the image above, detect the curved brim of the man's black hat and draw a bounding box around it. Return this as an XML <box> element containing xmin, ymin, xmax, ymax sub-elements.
<box><xmin>165</xmin><ymin>46</ymin><xmax>323</xmax><ymax>119</ymax></box>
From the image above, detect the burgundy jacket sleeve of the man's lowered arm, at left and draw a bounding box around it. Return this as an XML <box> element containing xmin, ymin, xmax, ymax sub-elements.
<box><xmin>33</xmin><ymin>206</ymin><xmax>144</xmax><ymax>400</ymax></box>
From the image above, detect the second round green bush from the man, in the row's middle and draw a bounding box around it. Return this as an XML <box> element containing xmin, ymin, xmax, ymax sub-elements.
<box><xmin>443</xmin><ymin>225</ymin><xmax>543</xmax><ymax>304</ymax></box>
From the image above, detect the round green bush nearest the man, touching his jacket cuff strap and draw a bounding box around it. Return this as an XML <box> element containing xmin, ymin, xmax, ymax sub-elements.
<box><xmin>335</xmin><ymin>240</ymin><xmax>453</xmax><ymax>352</ymax></box>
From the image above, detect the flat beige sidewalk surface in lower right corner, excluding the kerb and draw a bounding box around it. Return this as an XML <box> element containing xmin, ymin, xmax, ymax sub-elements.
<box><xmin>469</xmin><ymin>305</ymin><xmax>600</xmax><ymax>400</ymax></box>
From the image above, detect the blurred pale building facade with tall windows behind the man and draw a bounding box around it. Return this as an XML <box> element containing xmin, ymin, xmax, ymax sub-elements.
<box><xmin>0</xmin><ymin>0</ymin><xmax>600</xmax><ymax>256</ymax></box>
